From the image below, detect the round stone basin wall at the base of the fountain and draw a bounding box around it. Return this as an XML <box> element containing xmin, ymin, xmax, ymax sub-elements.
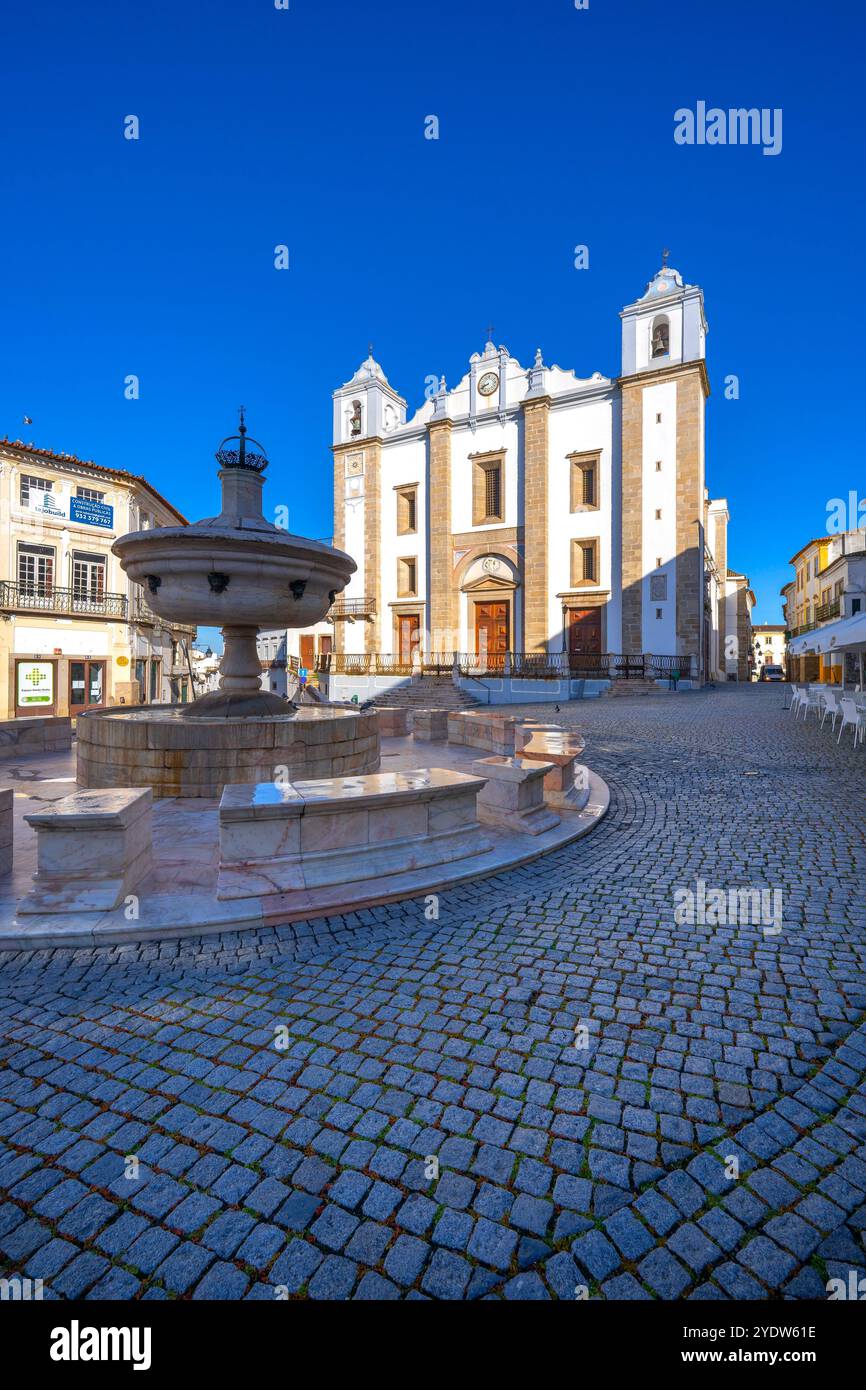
<box><xmin>78</xmin><ymin>703</ymin><xmax>379</xmax><ymax>796</ymax></box>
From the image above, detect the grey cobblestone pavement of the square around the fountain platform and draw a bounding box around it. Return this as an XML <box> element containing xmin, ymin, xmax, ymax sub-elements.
<box><xmin>0</xmin><ymin>687</ymin><xmax>866</xmax><ymax>1300</ymax></box>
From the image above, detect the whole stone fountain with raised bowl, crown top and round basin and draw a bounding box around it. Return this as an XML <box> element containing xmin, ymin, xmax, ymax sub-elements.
<box><xmin>78</xmin><ymin>411</ymin><xmax>379</xmax><ymax>796</ymax></box>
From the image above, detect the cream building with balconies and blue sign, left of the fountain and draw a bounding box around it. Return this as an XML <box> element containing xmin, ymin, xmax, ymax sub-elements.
<box><xmin>0</xmin><ymin>439</ymin><xmax>195</xmax><ymax>719</ymax></box>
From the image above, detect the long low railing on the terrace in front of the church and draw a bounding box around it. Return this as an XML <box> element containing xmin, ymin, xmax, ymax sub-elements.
<box><xmin>317</xmin><ymin>652</ymin><xmax>698</xmax><ymax>681</ymax></box>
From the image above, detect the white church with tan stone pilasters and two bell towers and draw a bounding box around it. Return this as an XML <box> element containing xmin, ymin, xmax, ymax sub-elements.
<box><xmin>332</xmin><ymin>265</ymin><xmax>749</xmax><ymax>681</ymax></box>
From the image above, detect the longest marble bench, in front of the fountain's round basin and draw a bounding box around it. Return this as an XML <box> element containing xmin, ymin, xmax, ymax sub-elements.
<box><xmin>217</xmin><ymin>767</ymin><xmax>491</xmax><ymax>898</ymax></box>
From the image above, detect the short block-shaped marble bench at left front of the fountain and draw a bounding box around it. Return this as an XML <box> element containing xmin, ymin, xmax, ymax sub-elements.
<box><xmin>18</xmin><ymin>787</ymin><xmax>153</xmax><ymax>913</ymax></box>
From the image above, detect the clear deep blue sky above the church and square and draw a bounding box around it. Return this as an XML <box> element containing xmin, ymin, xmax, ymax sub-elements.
<box><xmin>0</xmin><ymin>0</ymin><xmax>866</xmax><ymax>644</ymax></box>
